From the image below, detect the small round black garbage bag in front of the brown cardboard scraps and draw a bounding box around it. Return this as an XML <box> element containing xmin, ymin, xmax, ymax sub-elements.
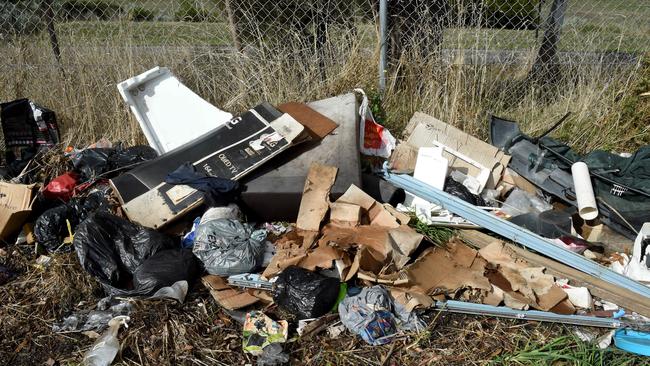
<box><xmin>273</xmin><ymin>266</ymin><xmax>340</xmax><ymax>319</ymax></box>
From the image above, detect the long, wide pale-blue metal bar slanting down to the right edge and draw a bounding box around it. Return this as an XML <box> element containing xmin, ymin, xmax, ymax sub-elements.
<box><xmin>385</xmin><ymin>172</ymin><xmax>650</xmax><ymax>301</ymax></box>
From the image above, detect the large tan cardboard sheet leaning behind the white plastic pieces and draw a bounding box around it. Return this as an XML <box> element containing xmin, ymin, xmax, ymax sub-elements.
<box><xmin>404</xmin><ymin>112</ymin><xmax>510</xmax><ymax>189</ymax></box>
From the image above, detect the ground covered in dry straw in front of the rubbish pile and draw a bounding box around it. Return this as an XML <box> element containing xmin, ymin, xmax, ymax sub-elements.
<box><xmin>0</xmin><ymin>245</ymin><xmax>636</xmax><ymax>365</ymax></box>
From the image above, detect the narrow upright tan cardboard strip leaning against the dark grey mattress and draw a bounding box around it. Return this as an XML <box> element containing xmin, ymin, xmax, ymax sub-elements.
<box><xmin>296</xmin><ymin>163</ymin><xmax>338</xmax><ymax>231</ymax></box>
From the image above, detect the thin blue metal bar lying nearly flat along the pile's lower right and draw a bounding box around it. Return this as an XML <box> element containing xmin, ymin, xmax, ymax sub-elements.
<box><xmin>436</xmin><ymin>300</ymin><xmax>636</xmax><ymax>328</ymax></box>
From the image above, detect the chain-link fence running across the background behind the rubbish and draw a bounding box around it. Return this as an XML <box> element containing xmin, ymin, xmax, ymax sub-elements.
<box><xmin>0</xmin><ymin>0</ymin><xmax>650</xmax><ymax>148</ymax></box>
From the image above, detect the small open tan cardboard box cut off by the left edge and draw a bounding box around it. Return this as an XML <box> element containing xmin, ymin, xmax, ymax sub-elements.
<box><xmin>0</xmin><ymin>182</ymin><xmax>34</xmax><ymax>240</ymax></box>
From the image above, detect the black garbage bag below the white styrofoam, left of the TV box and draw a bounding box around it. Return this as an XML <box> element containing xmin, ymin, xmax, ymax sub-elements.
<box><xmin>71</xmin><ymin>145</ymin><xmax>158</xmax><ymax>181</ymax></box>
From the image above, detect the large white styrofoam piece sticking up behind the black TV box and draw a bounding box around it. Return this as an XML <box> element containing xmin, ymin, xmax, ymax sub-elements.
<box><xmin>117</xmin><ymin>66</ymin><xmax>232</xmax><ymax>155</ymax></box>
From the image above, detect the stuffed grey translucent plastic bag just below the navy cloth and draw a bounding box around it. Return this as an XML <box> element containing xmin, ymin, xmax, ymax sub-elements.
<box><xmin>193</xmin><ymin>219</ymin><xmax>266</xmax><ymax>276</ymax></box>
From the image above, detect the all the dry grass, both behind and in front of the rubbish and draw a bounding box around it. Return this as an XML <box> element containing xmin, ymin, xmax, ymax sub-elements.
<box><xmin>0</xmin><ymin>15</ymin><xmax>650</xmax><ymax>365</ymax></box>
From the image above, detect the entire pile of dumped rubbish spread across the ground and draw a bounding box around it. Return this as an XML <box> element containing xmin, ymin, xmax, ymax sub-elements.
<box><xmin>0</xmin><ymin>67</ymin><xmax>650</xmax><ymax>365</ymax></box>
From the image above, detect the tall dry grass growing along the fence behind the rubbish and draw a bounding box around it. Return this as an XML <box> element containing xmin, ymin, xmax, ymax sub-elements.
<box><xmin>0</xmin><ymin>22</ymin><xmax>648</xmax><ymax>154</ymax></box>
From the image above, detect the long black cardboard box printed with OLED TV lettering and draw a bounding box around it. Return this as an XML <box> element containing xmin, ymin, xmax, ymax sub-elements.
<box><xmin>111</xmin><ymin>103</ymin><xmax>304</xmax><ymax>229</ymax></box>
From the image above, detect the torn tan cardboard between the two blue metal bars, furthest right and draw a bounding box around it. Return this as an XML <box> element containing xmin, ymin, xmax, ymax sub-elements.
<box><xmin>479</xmin><ymin>241</ymin><xmax>567</xmax><ymax>311</ymax></box>
